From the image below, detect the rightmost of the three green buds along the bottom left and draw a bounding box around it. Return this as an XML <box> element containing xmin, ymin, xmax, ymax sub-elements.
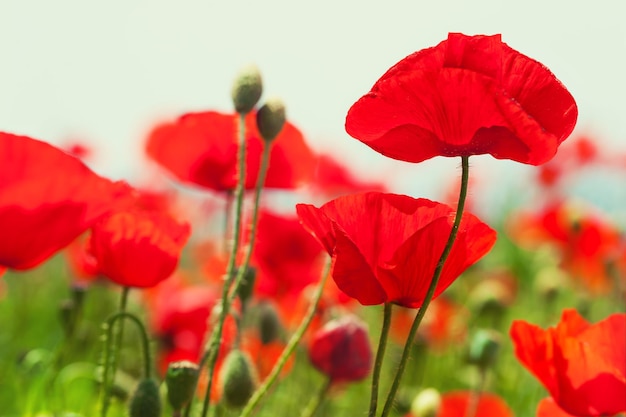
<box><xmin>220</xmin><ymin>349</ymin><xmax>258</xmax><ymax>408</ymax></box>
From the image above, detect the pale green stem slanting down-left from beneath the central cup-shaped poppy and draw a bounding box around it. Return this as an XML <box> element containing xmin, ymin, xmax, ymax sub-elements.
<box><xmin>239</xmin><ymin>260</ymin><xmax>331</xmax><ymax>417</ymax></box>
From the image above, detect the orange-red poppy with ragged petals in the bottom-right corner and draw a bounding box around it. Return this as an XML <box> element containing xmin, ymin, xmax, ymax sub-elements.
<box><xmin>511</xmin><ymin>310</ymin><xmax>626</xmax><ymax>416</ymax></box>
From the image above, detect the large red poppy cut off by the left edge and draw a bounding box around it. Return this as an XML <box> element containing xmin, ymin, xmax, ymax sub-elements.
<box><xmin>0</xmin><ymin>132</ymin><xmax>127</xmax><ymax>270</ymax></box>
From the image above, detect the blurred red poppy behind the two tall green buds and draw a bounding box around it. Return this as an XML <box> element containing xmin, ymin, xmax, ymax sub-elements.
<box><xmin>147</xmin><ymin>111</ymin><xmax>315</xmax><ymax>191</ymax></box>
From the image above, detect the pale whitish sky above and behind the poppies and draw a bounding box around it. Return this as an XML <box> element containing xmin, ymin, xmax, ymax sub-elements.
<box><xmin>0</xmin><ymin>0</ymin><xmax>626</xmax><ymax>218</ymax></box>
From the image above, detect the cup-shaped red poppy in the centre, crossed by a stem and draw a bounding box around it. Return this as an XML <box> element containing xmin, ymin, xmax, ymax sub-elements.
<box><xmin>297</xmin><ymin>193</ymin><xmax>496</xmax><ymax>308</ymax></box>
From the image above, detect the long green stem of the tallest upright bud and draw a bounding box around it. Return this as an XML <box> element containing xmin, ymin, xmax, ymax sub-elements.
<box><xmin>201</xmin><ymin>113</ymin><xmax>246</xmax><ymax>417</ymax></box>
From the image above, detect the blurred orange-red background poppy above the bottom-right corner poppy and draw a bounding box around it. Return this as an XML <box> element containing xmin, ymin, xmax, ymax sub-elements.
<box><xmin>509</xmin><ymin>202</ymin><xmax>624</xmax><ymax>293</ymax></box>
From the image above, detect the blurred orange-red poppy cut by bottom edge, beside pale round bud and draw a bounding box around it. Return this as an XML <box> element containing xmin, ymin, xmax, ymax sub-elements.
<box><xmin>437</xmin><ymin>391</ymin><xmax>513</xmax><ymax>417</ymax></box>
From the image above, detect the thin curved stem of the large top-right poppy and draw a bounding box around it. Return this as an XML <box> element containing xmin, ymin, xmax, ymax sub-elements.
<box><xmin>381</xmin><ymin>156</ymin><xmax>469</xmax><ymax>417</ymax></box>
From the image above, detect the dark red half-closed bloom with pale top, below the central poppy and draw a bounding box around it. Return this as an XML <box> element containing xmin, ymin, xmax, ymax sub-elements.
<box><xmin>309</xmin><ymin>315</ymin><xmax>372</xmax><ymax>383</ymax></box>
